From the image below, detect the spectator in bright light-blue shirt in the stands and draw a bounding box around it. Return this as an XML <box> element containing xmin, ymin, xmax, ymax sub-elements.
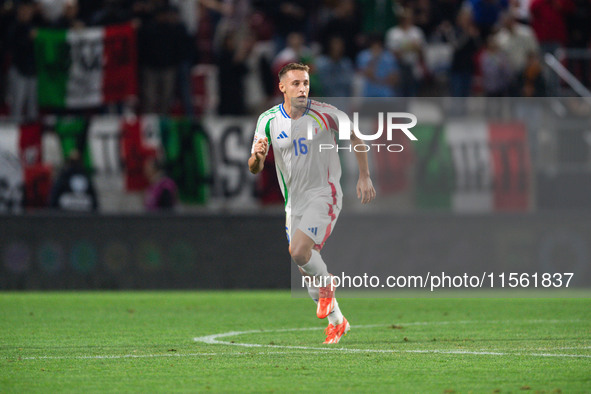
<box><xmin>357</xmin><ymin>35</ymin><xmax>398</xmax><ymax>97</ymax></box>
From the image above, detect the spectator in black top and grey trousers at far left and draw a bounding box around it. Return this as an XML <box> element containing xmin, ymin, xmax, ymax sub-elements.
<box><xmin>7</xmin><ymin>0</ymin><xmax>38</xmax><ymax>122</ymax></box>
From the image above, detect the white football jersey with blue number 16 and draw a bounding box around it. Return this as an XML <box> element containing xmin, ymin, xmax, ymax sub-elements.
<box><xmin>251</xmin><ymin>100</ymin><xmax>343</xmax><ymax>216</ymax></box>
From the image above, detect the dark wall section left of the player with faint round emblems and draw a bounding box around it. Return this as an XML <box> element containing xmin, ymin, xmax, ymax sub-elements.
<box><xmin>0</xmin><ymin>214</ymin><xmax>290</xmax><ymax>289</ymax></box>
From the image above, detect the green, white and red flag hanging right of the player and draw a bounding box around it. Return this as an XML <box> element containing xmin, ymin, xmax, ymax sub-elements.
<box><xmin>413</xmin><ymin>119</ymin><xmax>532</xmax><ymax>213</ymax></box>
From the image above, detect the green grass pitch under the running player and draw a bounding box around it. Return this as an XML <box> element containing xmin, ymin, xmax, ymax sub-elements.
<box><xmin>0</xmin><ymin>291</ymin><xmax>591</xmax><ymax>393</ymax></box>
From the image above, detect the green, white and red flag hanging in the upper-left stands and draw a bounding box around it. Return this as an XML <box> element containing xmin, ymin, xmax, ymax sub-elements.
<box><xmin>35</xmin><ymin>24</ymin><xmax>137</xmax><ymax>109</ymax></box>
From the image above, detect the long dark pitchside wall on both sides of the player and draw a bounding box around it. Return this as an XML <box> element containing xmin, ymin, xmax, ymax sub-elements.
<box><xmin>0</xmin><ymin>211</ymin><xmax>591</xmax><ymax>290</ymax></box>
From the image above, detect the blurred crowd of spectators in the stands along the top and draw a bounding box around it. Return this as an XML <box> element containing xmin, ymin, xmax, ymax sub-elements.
<box><xmin>0</xmin><ymin>0</ymin><xmax>591</xmax><ymax>119</ymax></box>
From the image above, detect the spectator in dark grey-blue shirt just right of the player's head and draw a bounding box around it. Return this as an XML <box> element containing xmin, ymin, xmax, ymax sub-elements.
<box><xmin>316</xmin><ymin>36</ymin><xmax>355</xmax><ymax>97</ymax></box>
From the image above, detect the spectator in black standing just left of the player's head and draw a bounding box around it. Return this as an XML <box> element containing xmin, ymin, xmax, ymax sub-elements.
<box><xmin>217</xmin><ymin>32</ymin><xmax>254</xmax><ymax>115</ymax></box>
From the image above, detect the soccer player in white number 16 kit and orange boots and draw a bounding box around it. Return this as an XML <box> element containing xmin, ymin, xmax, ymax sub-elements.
<box><xmin>248</xmin><ymin>63</ymin><xmax>376</xmax><ymax>343</ymax></box>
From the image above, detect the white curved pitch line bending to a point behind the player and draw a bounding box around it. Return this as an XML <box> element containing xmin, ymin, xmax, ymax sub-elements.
<box><xmin>193</xmin><ymin>320</ymin><xmax>591</xmax><ymax>358</ymax></box>
